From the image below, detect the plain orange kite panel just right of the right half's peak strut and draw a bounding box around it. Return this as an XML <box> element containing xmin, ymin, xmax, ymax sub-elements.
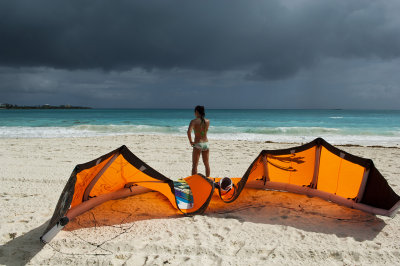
<box><xmin>317</xmin><ymin>147</ymin><xmax>342</xmax><ymax>194</ymax></box>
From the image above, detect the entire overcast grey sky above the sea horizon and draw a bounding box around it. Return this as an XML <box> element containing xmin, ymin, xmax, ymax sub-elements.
<box><xmin>0</xmin><ymin>0</ymin><xmax>400</xmax><ymax>109</ymax></box>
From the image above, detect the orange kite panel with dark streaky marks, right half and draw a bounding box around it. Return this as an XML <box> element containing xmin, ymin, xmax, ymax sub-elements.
<box><xmin>267</xmin><ymin>147</ymin><xmax>316</xmax><ymax>186</ymax></box>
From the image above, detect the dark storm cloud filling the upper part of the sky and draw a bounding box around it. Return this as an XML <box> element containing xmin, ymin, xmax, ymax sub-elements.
<box><xmin>0</xmin><ymin>0</ymin><xmax>400</xmax><ymax>80</ymax></box>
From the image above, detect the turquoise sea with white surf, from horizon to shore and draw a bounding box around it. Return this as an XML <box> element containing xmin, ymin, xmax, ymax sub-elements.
<box><xmin>0</xmin><ymin>109</ymin><xmax>400</xmax><ymax>146</ymax></box>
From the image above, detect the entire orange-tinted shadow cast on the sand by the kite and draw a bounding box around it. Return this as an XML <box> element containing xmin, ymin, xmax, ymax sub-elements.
<box><xmin>0</xmin><ymin>189</ymin><xmax>386</xmax><ymax>265</ymax></box>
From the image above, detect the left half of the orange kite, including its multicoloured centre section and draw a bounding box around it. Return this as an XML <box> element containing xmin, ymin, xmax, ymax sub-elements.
<box><xmin>41</xmin><ymin>145</ymin><xmax>214</xmax><ymax>242</ymax></box>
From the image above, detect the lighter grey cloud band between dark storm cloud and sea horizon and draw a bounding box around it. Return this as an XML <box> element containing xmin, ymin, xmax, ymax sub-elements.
<box><xmin>0</xmin><ymin>58</ymin><xmax>400</xmax><ymax>109</ymax></box>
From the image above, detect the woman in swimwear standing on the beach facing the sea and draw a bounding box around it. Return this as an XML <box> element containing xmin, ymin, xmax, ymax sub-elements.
<box><xmin>187</xmin><ymin>105</ymin><xmax>210</xmax><ymax>177</ymax></box>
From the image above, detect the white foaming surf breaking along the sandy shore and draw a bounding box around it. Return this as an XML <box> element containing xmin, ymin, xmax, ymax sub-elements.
<box><xmin>0</xmin><ymin>124</ymin><xmax>400</xmax><ymax>146</ymax></box>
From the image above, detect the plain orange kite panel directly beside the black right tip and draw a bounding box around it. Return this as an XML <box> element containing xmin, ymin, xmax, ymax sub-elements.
<box><xmin>336</xmin><ymin>159</ymin><xmax>365</xmax><ymax>198</ymax></box>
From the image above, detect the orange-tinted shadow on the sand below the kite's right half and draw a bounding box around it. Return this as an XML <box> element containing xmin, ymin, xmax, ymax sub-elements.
<box><xmin>207</xmin><ymin>189</ymin><xmax>386</xmax><ymax>241</ymax></box>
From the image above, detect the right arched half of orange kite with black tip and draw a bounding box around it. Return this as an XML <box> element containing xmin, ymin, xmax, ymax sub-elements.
<box><xmin>238</xmin><ymin>138</ymin><xmax>400</xmax><ymax>216</ymax></box>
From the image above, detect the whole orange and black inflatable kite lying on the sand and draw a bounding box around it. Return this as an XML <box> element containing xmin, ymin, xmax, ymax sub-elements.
<box><xmin>40</xmin><ymin>138</ymin><xmax>400</xmax><ymax>243</ymax></box>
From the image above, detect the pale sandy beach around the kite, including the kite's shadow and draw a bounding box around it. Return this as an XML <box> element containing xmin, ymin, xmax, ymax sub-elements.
<box><xmin>0</xmin><ymin>135</ymin><xmax>400</xmax><ymax>265</ymax></box>
